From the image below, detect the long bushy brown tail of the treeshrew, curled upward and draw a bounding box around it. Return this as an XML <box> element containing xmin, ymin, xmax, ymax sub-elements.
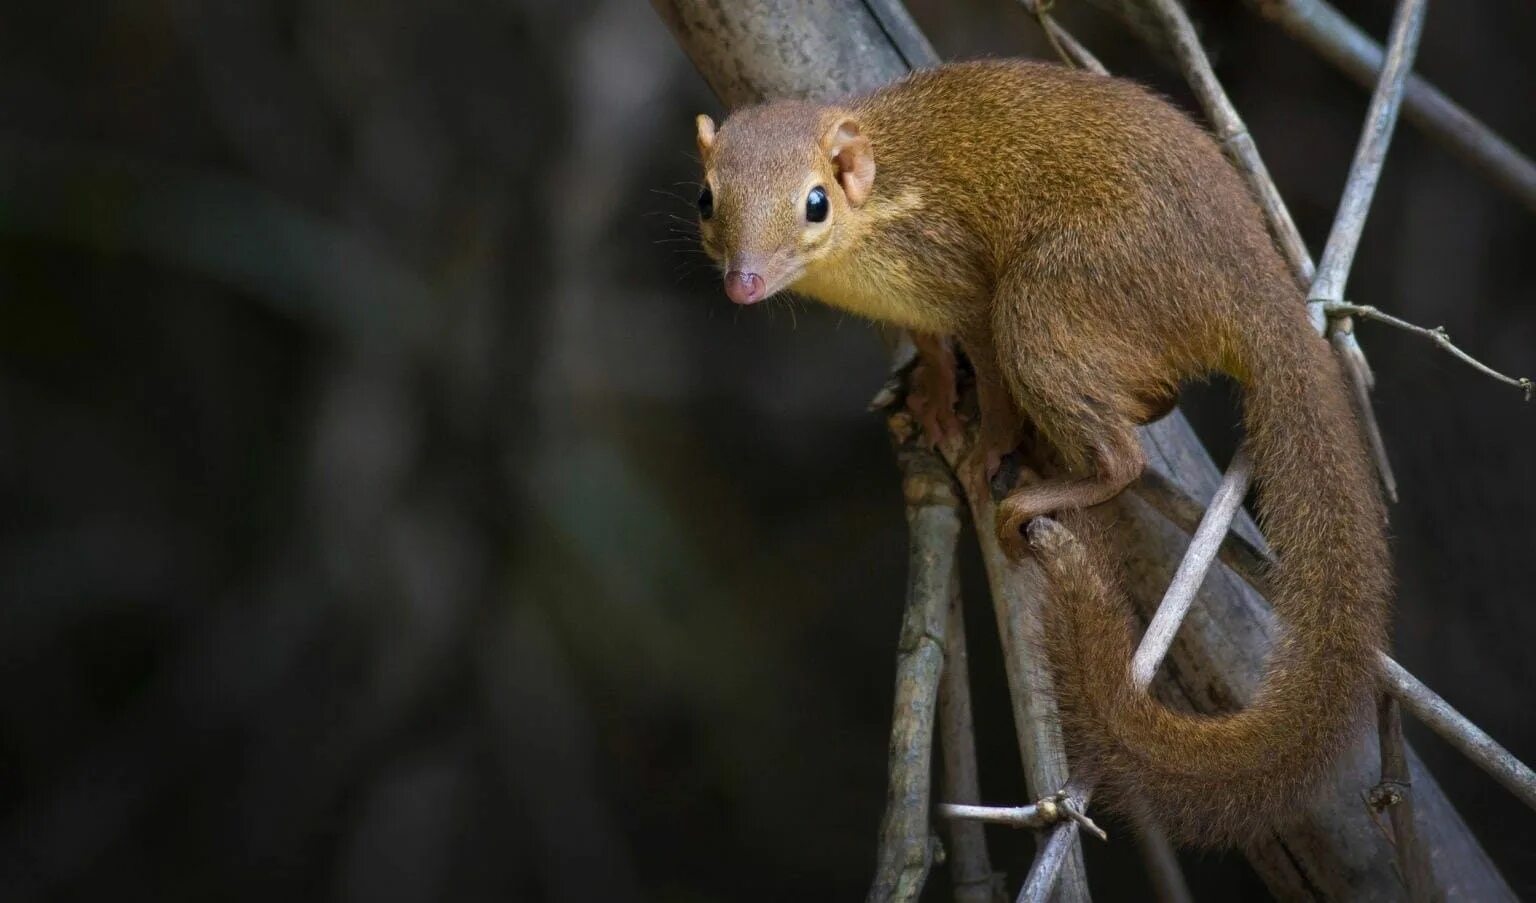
<box><xmin>1031</xmin><ymin>306</ymin><xmax>1390</xmax><ymax>846</ymax></box>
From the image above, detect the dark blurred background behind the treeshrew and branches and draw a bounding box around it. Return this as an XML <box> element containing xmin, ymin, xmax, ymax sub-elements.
<box><xmin>0</xmin><ymin>0</ymin><xmax>1536</xmax><ymax>901</ymax></box>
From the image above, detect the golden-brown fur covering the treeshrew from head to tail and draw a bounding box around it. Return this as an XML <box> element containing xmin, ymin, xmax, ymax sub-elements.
<box><xmin>700</xmin><ymin>61</ymin><xmax>1390</xmax><ymax>845</ymax></box>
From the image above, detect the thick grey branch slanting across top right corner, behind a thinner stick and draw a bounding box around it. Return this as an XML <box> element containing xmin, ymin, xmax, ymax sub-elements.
<box><xmin>1247</xmin><ymin>0</ymin><xmax>1536</xmax><ymax>210</ymax></box>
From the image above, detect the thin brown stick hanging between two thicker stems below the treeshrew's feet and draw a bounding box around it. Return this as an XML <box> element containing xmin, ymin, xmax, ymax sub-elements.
<box><xmin>938</xmin><ymin>581</ymin><xmax>1001</xmax><ymax>903</ymax></box>
